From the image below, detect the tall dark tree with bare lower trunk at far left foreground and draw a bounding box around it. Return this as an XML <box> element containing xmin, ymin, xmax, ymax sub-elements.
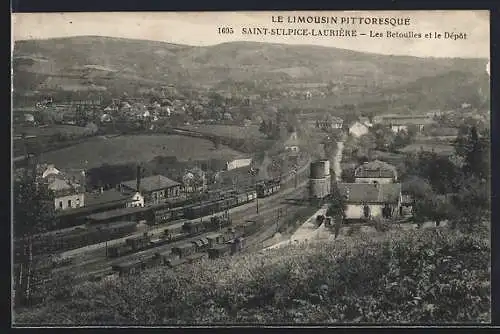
<box><xmin>13</xmin><ymin>164</ymin><xmax>55</xmax><ymax>305</ymax></box>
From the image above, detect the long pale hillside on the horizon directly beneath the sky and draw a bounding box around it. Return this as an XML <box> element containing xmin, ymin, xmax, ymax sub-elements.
<box><xmin>14</xmin><ymin>36</ymin><xmax>485</xmax><ymax>101</ymax></box>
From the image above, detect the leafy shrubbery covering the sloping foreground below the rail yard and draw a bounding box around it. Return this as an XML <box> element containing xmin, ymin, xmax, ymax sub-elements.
<box><xmin>15</xmin><ymin>229</ymin><xmax>490</xmax><ymax>325</ymax></box>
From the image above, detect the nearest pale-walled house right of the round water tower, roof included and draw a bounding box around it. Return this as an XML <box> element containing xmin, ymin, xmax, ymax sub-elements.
<box><xmin>338</xmin><ymin>183</ymin><xmax>402</xmax><ymax>220</ymax></box>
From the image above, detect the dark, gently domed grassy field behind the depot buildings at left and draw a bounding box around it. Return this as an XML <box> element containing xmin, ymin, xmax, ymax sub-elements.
<box><xmin>38</xmin><ymin>135</ymin><xmax>240</xmax><ymax>168</ymax></box>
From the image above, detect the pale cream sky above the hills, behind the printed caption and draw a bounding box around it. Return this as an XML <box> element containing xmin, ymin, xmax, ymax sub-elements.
<box><xmin>12</xmin><ymin>10</ymin><xmax>490</xmax><ymax>59</ymax></box>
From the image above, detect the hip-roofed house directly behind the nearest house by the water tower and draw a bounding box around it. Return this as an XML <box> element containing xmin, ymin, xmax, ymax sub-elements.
<box><xmin>354</xmin><ymin>160</ymin><xmax>398</xmax><ymax>184</ymax></box>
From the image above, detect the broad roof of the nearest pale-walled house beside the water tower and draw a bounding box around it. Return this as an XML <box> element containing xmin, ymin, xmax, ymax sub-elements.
<box><xmin>339</xmin><ymin>183</ymin><xmax>401</xmax><ymax>204</ymax></box>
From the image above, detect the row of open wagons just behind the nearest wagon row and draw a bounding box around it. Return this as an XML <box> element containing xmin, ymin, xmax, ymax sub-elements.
<box><xmin>107</xmin><ymin>212</ymin><xmax>232</xmax><ymax>258</ymax></box>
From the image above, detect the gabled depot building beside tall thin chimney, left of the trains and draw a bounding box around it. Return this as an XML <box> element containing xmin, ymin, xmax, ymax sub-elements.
<box><xmin>119</xmin><ymin>175</ymin><xmax>182</xmax><ymax>205</ymax></box>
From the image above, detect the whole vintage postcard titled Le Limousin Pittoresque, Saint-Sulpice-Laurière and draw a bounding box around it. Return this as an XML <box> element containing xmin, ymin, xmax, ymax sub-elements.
<box><xmin>12</xmin><ymin>10</ymin><xmax>491</xmax><ymax>327</ymax></box>
